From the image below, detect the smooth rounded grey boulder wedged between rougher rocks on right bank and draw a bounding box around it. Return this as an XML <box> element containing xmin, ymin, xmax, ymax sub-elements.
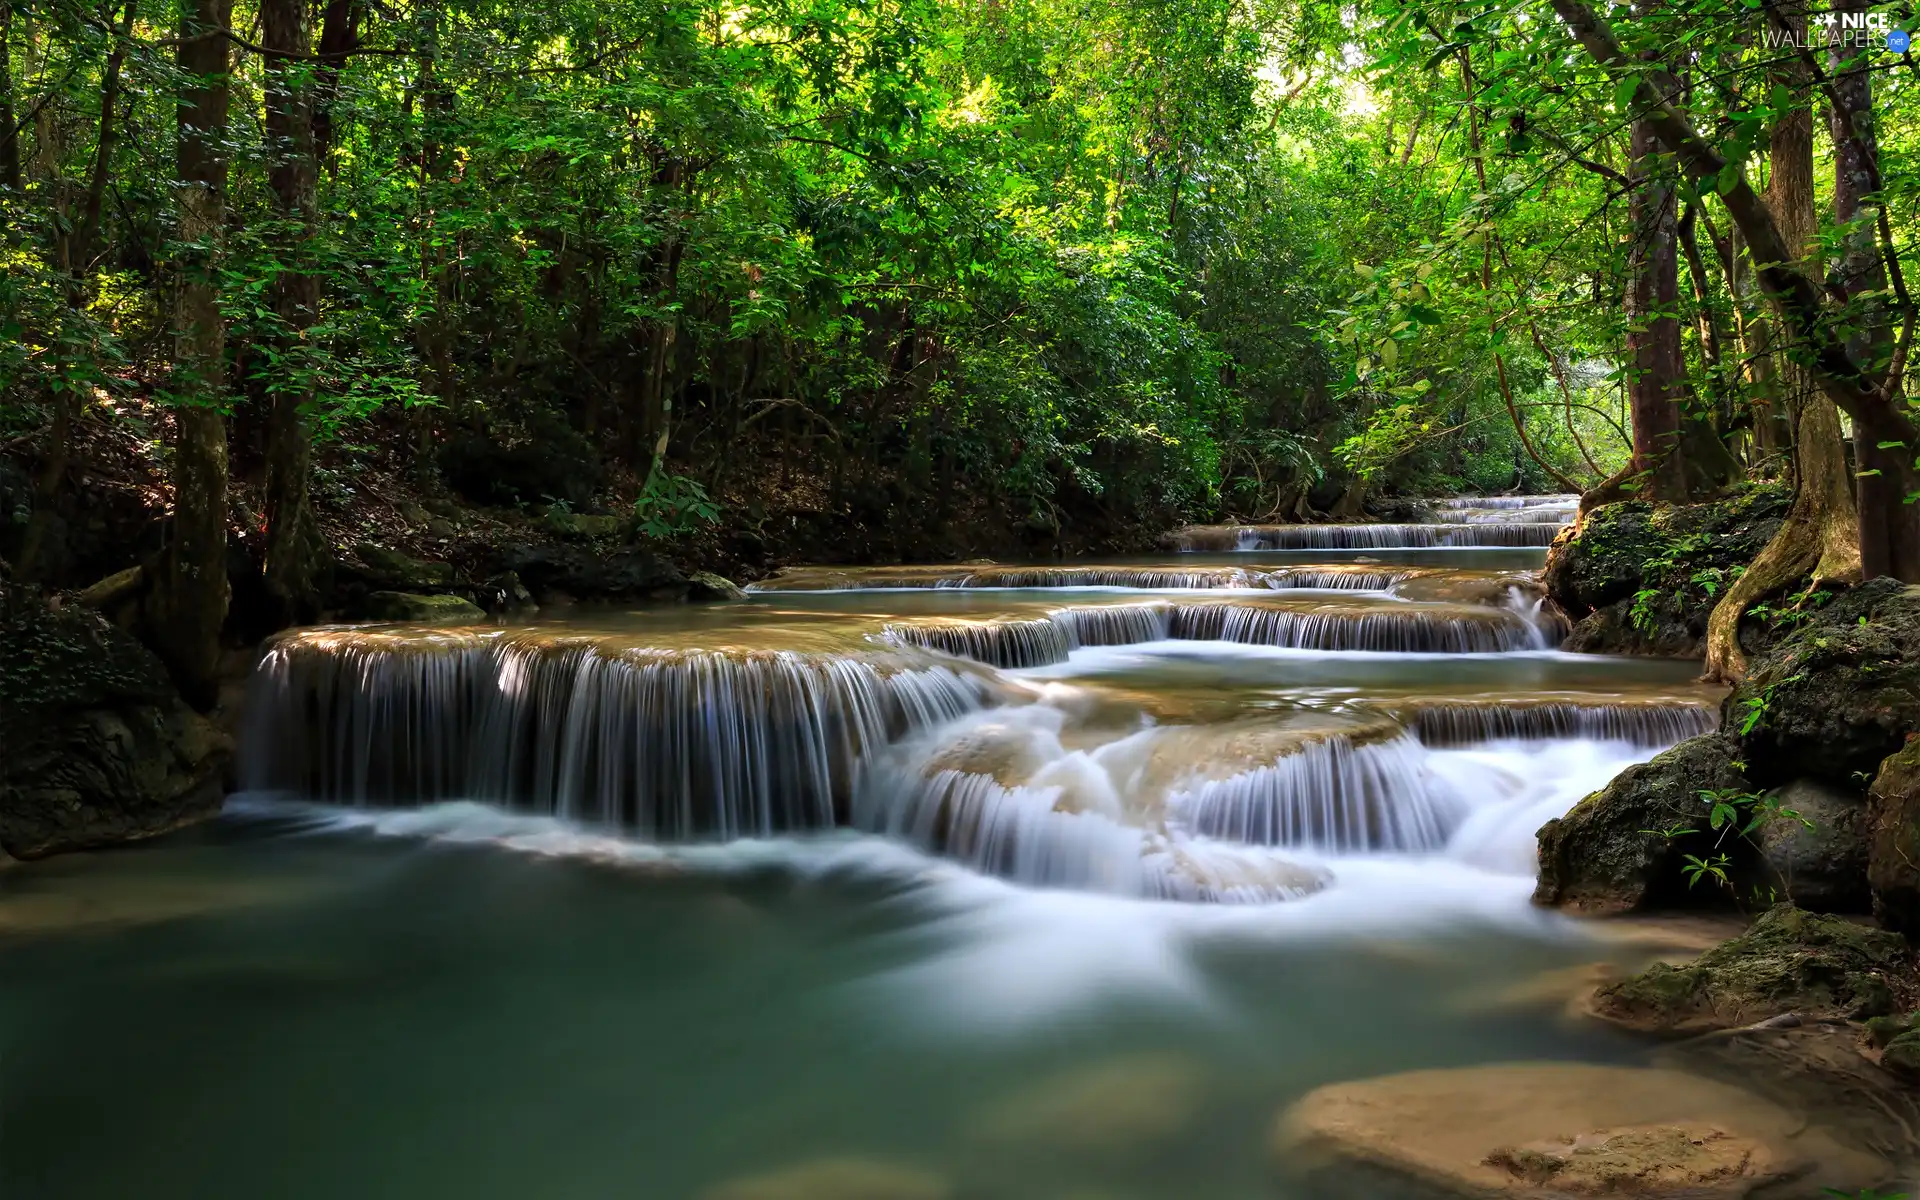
<box><xmin>1753</xmin><ymin>780</ymin><xmax>1872</xmax><ymax>912</ymax></box>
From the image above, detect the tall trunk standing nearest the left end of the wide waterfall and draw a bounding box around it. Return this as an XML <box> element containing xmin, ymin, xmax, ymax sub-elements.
<box><xmin>259</xmin><ymin>0</ymin><xmax>321</xmax><ymax>624</ymax></box>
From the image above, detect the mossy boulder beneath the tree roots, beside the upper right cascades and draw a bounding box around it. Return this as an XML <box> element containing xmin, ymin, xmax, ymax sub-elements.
<box><xmin>1544</xmin><ymin>484</ymin><xmax>1791</xmax><ymax>657</ymax></box>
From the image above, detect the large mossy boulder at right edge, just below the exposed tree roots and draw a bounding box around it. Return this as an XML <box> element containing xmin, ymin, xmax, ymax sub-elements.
<box><xmin>1720</xmin><ymin>578</ymin><xmax>1920</xmax><ymax>789</ymax></box>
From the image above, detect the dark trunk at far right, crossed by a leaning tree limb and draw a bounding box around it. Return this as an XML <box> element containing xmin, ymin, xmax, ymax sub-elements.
<box><xmin>1828</xmin><ymin>0</ymin><xmax>1920</xmax><ymax>584</ymax></box>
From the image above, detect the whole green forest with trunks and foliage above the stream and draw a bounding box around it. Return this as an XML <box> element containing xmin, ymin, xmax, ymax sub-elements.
<box><xmin>0</xmin><ymin>0</ymin><xmax>1920</xmax><ymax>689</ymax></box>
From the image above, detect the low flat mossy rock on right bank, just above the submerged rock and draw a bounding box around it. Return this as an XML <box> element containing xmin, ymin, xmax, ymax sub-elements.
<box><xmin>1594</xmin><ymin>904</ymin><xmax>1920</xmax><ymax>1035</ymax></box>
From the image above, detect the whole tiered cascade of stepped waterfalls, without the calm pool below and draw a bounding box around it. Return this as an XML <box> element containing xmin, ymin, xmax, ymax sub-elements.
<box><xmin>246</xmin><ymin>497</ymin><xmax>1715</xmax><ymax>902</ymax></box>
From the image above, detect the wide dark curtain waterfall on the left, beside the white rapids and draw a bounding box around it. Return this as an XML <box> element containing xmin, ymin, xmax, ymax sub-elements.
<box><xmin>244</xmin><ymin>630</ymin><xmax>987</xmax><ymax>837</ymax></box>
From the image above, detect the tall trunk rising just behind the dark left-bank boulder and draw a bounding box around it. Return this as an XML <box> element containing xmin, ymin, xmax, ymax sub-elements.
<box><xmin>152</xmin><ymin>0</ymin><xmax>232</xmax><ymax>708</ymax></box>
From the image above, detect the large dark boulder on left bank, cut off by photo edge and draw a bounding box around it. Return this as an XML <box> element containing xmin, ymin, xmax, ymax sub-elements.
<box><xmin>0</xmin><ymin>593</ymin><xmax>232</xmax><ymax>858</ymax></box>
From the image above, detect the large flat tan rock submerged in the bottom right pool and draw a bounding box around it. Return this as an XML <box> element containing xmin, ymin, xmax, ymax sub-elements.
<box><xmin>1277</xmin><ymin>1064</ymin><xmax>1860</xmax><ymax>1200</ymax></box>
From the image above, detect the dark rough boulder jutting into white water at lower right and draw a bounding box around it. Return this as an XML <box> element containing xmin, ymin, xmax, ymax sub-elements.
<box><xmin>1534</xmin><ymin>733</ymin><xmax>1759</xmax><ymax>916</ymax></box>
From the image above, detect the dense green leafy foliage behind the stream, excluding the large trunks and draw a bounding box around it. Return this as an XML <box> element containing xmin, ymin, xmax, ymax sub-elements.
<box><xmin>0</xmin><ymin>0</ymin><xmax>1920</xmax><ymax>552</ymax></box>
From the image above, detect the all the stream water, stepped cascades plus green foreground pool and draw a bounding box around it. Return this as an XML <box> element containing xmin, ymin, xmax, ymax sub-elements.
<box><xmin>0</xmin><ymin>497</ymin><xmax>1718</xmax><ymax>1200</ymax></box>
